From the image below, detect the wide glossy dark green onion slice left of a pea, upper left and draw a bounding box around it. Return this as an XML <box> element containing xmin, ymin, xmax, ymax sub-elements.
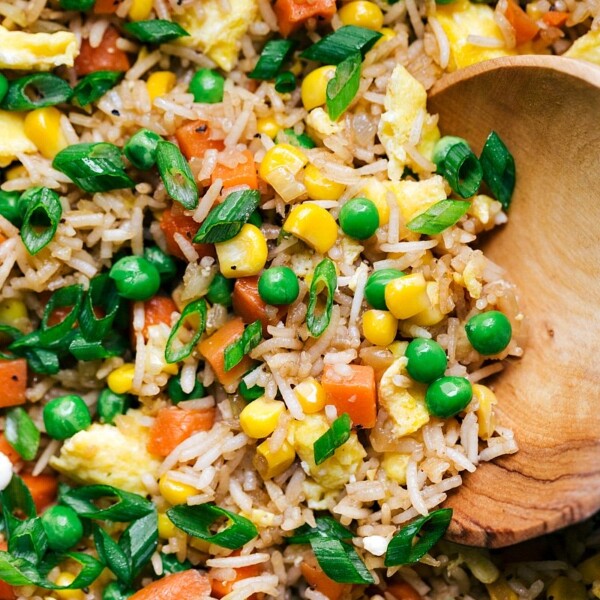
<box><xmin>52</xmin><ymin>142</ymin><xmax>135</xmax><ymax>194</ymax></box>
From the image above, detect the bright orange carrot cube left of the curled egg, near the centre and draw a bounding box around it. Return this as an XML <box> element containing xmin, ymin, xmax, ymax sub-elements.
<box><xmin>321</xmin><ymin>365</ymin><xmax>377</xmax><ymax>428</ymax></box>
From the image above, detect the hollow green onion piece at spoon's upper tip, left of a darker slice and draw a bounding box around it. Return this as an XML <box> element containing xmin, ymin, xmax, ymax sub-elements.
<box><xmin>433</xmin><ymin>136</ymin><xmax>483</xmax><ymax>198</ymax></box>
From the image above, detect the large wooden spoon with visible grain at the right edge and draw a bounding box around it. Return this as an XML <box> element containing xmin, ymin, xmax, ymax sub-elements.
<box><xmin>429</xmin><ymin>56</ymin><xmax>600</xmax><ymax>547</ymax></box>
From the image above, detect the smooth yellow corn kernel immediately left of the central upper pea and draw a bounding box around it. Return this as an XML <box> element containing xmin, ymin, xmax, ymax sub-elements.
<box><xmin>283</xmin><ymin>203</ymin><xmax>337</xmax><ymax>254</ymax></box>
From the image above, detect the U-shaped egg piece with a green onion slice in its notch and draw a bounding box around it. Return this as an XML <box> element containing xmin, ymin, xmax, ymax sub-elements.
<box><xmin>288</xmin><ymin>413</ymin><xmax>367</xmax><ymax>490</ymax></box>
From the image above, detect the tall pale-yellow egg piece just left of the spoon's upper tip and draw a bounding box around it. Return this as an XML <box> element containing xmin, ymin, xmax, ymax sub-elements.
<box><xmin>378</xmin><ymin>65</ymin><xmax>440</xmax><ymax>181</ymax></box>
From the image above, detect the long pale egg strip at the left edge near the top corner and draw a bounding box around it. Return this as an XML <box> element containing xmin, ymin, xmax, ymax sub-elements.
<box><xmin>0</xmin><ymin>26</ymin><xmax>79</xmax><ymax>71</ymax></box>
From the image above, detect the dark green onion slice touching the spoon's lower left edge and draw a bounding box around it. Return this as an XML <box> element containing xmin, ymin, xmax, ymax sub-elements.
<box><xmin>384</xmin><ymin>508</ymin><xmax>452</xmax><ymax>567</ymax></box>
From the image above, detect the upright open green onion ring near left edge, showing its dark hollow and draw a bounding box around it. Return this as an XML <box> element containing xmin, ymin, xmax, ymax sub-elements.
<box><xmin>19</xmin><ymin>187</ymin><xmax>62</xmax><ymax>255</ymax></box>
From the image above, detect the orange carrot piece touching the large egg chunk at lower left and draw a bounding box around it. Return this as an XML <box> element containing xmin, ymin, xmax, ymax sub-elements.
<box><xmin>148</xmin><ymin>406</ymin><xmax>215</xmax><ymax>456</ymax></box>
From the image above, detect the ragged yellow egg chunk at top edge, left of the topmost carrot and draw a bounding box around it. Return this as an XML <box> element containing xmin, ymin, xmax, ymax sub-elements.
<box><xmin>174</xmin><ymin>0</ymin><xmax>258</xmax><ymax>71</ymax></box>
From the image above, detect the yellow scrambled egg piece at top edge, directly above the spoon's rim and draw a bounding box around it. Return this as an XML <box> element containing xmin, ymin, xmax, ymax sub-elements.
<box><xmin>436</xmin><ymin>0</ymin><xmax>516</xmax><ymax>71</ymax></box>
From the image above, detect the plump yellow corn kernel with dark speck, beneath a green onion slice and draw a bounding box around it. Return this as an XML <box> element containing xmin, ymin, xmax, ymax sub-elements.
<box><xmin>215</xmin><ymin>223</ymin><xmax>268</xmax><ymax>278</ymax></box>
